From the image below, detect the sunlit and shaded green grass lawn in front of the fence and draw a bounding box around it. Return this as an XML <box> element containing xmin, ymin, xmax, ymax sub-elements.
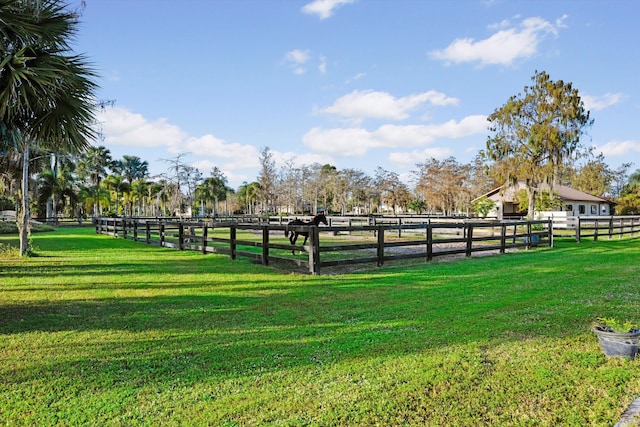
<box><xmin>0</xmin><ymin>228</ymin><xmax>640</xmax><ymax>426</ymax></box>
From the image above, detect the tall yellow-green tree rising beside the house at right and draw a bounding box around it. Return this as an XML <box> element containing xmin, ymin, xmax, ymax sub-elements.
<box><xmin>483</xmin><ymin>71</ymin><xmax>593</xmax><ymax>217</ymax></box>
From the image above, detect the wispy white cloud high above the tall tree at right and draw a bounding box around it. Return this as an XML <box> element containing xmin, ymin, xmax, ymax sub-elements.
<box><xmin>429</xmin><ymin>16</ymin><xmax>566</xmax><ymax>66</ymax></box>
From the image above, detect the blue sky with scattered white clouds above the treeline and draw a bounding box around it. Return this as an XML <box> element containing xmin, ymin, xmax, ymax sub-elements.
<box><xmin>74</xmin><ymin>0</ymin><xmax>640</xmax><ymax>188</ymax></box>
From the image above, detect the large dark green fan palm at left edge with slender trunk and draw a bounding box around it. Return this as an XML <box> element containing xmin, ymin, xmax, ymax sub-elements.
<box><xmin>0</xmin><ymin>0</ymin><xmax>97</xmax><ymax>255</ymax></box>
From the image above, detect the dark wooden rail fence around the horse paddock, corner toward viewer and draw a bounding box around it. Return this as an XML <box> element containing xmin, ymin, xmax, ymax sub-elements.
<box><xmin>94</xmin><ymin>218</ymin><xmax>553</xmax><ymax>274</ymax></box>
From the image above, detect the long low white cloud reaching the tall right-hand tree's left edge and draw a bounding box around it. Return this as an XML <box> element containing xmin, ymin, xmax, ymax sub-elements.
<box><xmin>302</xmin><ymin>115</ymin><xmax>487</xmax><ymax>157</ymax></box>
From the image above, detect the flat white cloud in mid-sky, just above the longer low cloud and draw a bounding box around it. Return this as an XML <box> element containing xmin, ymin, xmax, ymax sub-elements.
<box><xmin>321</xmin><ymin>90</ymin><xmax>459</xmax><ymax>120</ymax></box>
